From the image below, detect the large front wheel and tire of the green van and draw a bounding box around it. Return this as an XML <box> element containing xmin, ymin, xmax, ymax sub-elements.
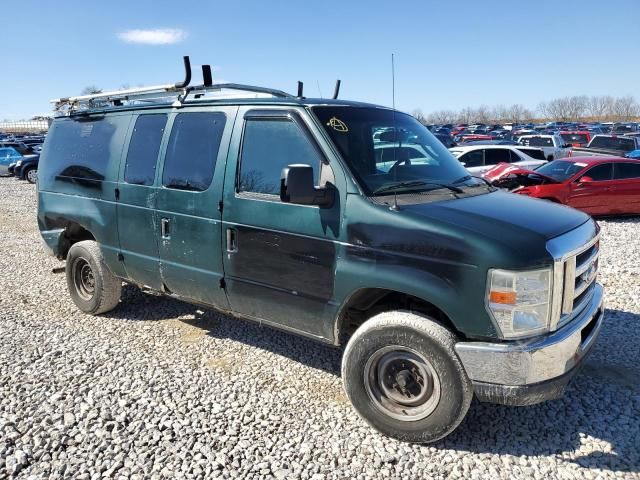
<box><xmin>342</xmin><ymin>311</ymin><xmax>473</xmax><ymax>443</ymax></box>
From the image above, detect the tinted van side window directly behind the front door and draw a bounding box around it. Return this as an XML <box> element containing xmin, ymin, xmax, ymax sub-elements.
<box><xmin>162</xmin><ymin>112</ymin><xmax>226</xmax><ymax>192</ymax></box>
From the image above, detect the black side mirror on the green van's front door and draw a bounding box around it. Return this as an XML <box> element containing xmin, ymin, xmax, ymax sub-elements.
<box><xmin>280</xmin><ymin>164</ymin><xmax>335</xmax><ymax>207</ymax></box>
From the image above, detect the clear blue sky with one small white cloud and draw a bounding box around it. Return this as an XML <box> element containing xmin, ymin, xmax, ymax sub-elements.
<box><xmin>0</xmin><ymin>0</ymin><xmax>640</xmax><ymax>119</ymax></box>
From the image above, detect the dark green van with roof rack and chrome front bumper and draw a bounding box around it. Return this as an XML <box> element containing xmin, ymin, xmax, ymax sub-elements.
<box><xmin>38</xmin><ymin>64</ymin><xmax>604</xmax><ymax>442</ymax></box>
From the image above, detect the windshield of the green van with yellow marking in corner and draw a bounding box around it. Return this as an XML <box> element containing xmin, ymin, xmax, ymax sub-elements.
<box><xmin>312</xmin><ymin>106</ymin><xmax>478</xmax><ymax>196</ymax></box>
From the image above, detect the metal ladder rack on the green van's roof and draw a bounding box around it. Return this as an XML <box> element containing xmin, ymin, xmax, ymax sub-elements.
<box><xmin>51</xmin><ymin>56</ymin><xmax>296</xmax><ymax>115</ymax></box>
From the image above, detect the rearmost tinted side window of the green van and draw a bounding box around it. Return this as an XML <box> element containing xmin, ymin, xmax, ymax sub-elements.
<box><xmin>46</xmin><ymin>115</ymin><xmax>131</xmax><ymax>181</ymax></box>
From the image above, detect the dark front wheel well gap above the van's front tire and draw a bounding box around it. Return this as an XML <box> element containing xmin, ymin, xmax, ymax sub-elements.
<box><xmin>336</xmin><ymin>288</ymin><xmax>463</xmax><ymax>344</ymax></box>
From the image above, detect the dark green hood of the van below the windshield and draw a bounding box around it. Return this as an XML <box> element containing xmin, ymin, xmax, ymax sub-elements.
<box><xmin>401</xmin><ymin>191</ymin><xmax>590</xmax><ymax>242</ymax></box>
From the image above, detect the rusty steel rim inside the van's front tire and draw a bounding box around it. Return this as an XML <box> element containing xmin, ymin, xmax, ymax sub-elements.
<box><xmin>364</xmin><ymin>346</ymin><xmax>440</xmax><ymax>422</ymax></box>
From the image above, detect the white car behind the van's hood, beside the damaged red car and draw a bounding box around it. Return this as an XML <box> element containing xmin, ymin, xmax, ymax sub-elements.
<box><xmin>449</xmin><ymin>145</ymin><xmax>547</xmax><ymax>175</ymax></box>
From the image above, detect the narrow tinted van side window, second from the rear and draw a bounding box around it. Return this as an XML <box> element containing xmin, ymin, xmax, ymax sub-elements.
<box><xmin>124</xmin><ymin>114</ymin><xmax>167</xmax><ymax>185</ymax></box>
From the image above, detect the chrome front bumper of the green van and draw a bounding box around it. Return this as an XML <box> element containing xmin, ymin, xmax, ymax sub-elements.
<box><xmin>456</xmin><ymin>284</ymin><xmax>604</xmax><ymax>405</ymax></box>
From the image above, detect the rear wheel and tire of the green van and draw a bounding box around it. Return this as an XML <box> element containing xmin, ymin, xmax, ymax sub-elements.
<box><xmin>66</xmin><ymin>240</ymin><xmax>122</xmax><ymax>315</ymax></box>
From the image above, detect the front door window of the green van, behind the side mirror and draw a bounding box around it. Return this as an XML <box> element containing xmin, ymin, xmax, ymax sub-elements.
<box><xmin>238</xmin><ymin>118</ymin><xmax>322</xmax><ymax>195</ymax></box>
